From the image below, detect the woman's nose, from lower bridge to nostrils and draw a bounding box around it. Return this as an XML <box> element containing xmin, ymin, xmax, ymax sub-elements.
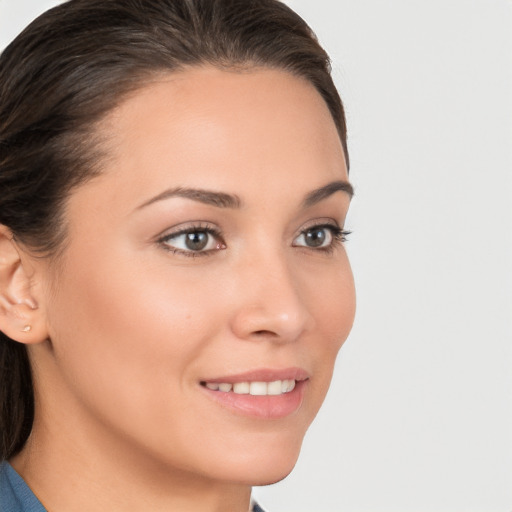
<box><xmin>231</xmin><ymin>251</ymin><xmax>314</xmax><ymax>343</ymax></box>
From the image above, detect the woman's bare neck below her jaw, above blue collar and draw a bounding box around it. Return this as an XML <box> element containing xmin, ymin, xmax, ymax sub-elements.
<box><xmin>10</xmin><ymin>416</ymin><xmax>251</xmax><ymax>512</ymax></box>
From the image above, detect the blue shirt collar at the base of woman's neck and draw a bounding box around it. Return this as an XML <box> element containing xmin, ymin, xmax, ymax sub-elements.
<box><xmin>0</xmin><ymin>461</ymin><xmax>264</xmax><ymax>512</ymax></box>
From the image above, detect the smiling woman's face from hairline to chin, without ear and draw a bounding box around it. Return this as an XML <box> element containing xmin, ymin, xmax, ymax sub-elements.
<box><xmin>32</xmin><ymin>67</ymin><xmax>355</xmax><ymax>484</ymax></box>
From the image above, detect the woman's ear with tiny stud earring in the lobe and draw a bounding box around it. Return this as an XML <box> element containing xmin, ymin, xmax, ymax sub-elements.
<box><xmin>0</xmin><ymin>224</ymin><xmax>47</xmax><ymax>344</ymax></box>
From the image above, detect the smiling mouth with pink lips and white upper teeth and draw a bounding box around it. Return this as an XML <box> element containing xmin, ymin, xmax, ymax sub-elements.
<box><xmin>200</xmin><ymin>368</ymin><xmax>309</xmax><ymax>419</ymax></box>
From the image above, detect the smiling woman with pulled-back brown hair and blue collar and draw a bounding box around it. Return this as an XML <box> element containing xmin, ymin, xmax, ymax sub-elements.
<box><xmin>0</xmin><ymin>0</ymin><xmax>355</xmax><ymax>512</ymax></box>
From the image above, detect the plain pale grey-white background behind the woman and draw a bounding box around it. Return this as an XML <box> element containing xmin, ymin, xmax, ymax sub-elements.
<box><xmin>0</xmin><ymin>0</ymin><xmax>512</xmax><ymax>512</ymax></box>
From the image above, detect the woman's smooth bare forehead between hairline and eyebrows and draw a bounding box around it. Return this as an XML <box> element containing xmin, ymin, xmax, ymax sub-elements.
<box><xmin>83</xmin><ymin>67</ymin><xmax>346</xmax><ymax>210</ymax></box>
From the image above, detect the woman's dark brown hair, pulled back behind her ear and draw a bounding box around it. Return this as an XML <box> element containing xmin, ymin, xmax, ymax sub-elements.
<box><xmin>0</xmin><ymin>0</ymin><xmax>348</xmax><ymax>460</ymax></box>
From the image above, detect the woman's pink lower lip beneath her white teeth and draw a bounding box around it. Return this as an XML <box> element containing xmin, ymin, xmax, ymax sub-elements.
<box><xmin>201</xmin><ymin>380</ymin><xmax>307</xmax><ymax>419</ymax></box>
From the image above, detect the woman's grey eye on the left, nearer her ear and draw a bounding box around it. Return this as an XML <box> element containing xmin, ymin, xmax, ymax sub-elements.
<box><xmin>159</xmin><ymin>226</ymin><xmax>225</xmax><ymax>256</ymax></box>
